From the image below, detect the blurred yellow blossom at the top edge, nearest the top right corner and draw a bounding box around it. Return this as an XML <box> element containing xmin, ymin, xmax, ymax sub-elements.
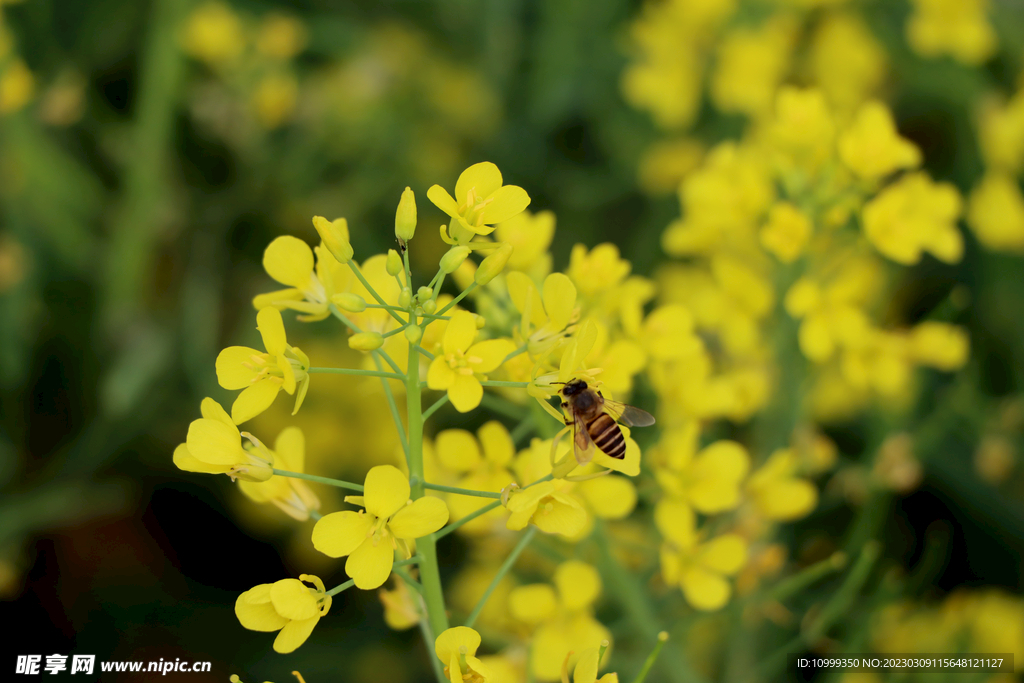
<box><xmin>906</xmin><ymin>0</ymin><xmax>996</xmax><ymax>65</ymax></box>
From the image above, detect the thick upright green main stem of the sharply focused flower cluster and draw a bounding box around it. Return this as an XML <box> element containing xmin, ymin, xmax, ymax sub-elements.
<box><xmin>398</xmin><ymin>344</ymin><xmax>449</xmax><ymax>651</ymax></box>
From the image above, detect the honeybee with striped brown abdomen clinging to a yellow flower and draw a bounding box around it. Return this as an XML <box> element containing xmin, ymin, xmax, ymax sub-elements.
<box><xmin>558</xmin><ymin>379</ymin><xmax>654</xmax><ymax>465</ymax></box>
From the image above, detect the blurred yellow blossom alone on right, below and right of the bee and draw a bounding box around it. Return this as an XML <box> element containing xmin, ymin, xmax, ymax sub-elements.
<box><xmin>746</xmin><ymin>449</ymin><xmax>818</xmax><ymax>521</ymax></box>
